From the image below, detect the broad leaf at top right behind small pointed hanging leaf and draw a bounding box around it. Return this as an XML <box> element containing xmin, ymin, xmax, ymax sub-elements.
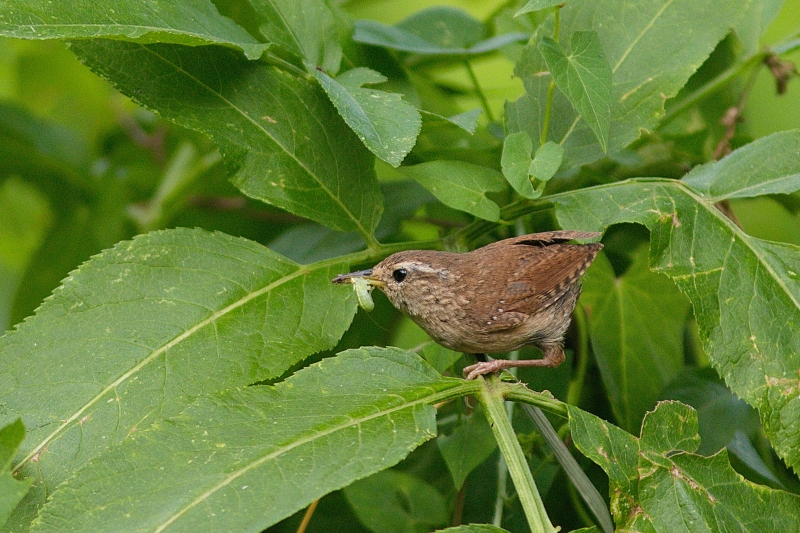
<box><xmin>506</xmin><ymin>0</ymin><xmax>750</xmax><ymax>168</ymax></box>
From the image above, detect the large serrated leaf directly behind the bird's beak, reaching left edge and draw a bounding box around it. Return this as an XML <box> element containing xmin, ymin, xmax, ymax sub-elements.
<box><xmin>0</xmin><ymin>230</ymin><xmax>356</xmax><ymax>523</ymax></box>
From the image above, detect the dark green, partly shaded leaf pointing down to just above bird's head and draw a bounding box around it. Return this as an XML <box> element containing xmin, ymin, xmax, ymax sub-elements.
<box><xmin>72</xmin><ymin>40</ymin><xmax>383</xmax><ymax>240</ymax></box>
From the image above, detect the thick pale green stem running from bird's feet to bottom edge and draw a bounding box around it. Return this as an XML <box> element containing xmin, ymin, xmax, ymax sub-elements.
<box><xmin>477</xmin><ymin>376</ymin><xmax>557</xmax><ymax>533</ymax></box>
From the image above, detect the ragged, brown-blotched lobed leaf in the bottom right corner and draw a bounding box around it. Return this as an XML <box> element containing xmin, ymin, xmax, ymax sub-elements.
<box><xmin>568</xmin><ymin>402</ymin><xmax>800</xmax><ymax>533</ymax></box>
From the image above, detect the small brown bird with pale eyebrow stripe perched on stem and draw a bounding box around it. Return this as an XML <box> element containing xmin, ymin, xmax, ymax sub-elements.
<box><xmin>333</xmin><ymin>231</ymin><xmax>603</xmax><ymax>379</ymax></box>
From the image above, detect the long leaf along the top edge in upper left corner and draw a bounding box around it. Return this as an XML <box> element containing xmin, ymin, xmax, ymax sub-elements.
<box><xmin>0</xmin><ymin>0</ymin><xmax>269</xmax><ymax>59</ymax></box>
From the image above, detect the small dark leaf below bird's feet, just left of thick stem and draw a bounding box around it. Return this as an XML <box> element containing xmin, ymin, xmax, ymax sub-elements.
<box><xmin>437</xmin><ymin>412</ymin><xmax>497</xmax><ymax>489</ymax></box>
